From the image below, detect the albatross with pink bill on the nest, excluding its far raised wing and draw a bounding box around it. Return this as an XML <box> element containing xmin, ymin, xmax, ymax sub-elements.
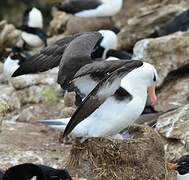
<box><xmin>41</xmin><ymin>60</ymin><xmax>157</xmax><ymax>138</ymax></box>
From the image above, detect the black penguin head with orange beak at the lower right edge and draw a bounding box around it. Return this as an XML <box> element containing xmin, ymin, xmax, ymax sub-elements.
<box><xmin>168</xmin><ymin>154</ymin><xmax>189</xmax><ymax>175</ymax></box>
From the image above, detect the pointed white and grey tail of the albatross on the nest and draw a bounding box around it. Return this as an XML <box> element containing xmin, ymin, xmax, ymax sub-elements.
<box><xmin>38</xmin><ymin>118</ymin><xmax>70</xmax><ymax>132</ymax></box>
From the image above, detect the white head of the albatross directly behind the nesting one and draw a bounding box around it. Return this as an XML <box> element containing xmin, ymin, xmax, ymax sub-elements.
<box><xmin>99</xmin><ymin>30</ymin><xmax>118</xmax><ymax>57</ymax></box>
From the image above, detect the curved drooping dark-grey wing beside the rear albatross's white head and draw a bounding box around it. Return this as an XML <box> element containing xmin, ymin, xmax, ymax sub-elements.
<box><xmin>58</xmin><ymin>32</ymin><xmax>103</xmax><ymax>89</ymax></box>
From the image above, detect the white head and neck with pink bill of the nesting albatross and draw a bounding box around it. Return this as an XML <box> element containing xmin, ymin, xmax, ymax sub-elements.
<box><xmin>121</xmin><ymin>62</ymin><xmax>158</xmax><ymax>105</ymax></box>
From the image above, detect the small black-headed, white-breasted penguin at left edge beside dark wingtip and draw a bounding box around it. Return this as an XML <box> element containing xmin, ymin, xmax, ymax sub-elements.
<box><xmin>3</xmin><ymin>47</ymin><xmax>25</xmax><ymax>80</ymax></box>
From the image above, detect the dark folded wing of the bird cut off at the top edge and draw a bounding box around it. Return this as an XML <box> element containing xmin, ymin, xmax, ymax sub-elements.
<box><xmin>57</xmin><ymin>0</ymin><xmax>102</xmax><ymax>14</ymax></box>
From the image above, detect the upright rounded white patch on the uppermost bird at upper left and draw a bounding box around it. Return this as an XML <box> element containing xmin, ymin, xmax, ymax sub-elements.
<box><xmin>27</xmin><ymin>7</ymin><xmax>43</xmax><ymax>29</ymax></box>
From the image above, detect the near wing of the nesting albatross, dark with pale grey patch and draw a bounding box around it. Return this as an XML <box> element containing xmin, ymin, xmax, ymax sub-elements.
<box><xmin>64</xmin><ymin>60</ymin><xmax>143</xmax><ymax>137</ymax></box>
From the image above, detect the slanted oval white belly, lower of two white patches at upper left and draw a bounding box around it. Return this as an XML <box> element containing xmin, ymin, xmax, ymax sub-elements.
<box><xmin>22</xmin><ymin>32</ymin><xmax>43</xmax><ymax>47</ymax></box>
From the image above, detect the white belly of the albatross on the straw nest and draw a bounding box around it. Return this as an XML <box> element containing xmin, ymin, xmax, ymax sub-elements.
<box><xmin>74</xmin><ymin>97</ymin><xmax>145</xmax><ymax>137</ymax></box>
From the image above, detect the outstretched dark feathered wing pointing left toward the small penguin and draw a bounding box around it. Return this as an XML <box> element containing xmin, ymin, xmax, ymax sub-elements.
<box><xmin>13</xmin><ymin>34</ymin><xmax>81</xmax><ymax>77</ymax></box>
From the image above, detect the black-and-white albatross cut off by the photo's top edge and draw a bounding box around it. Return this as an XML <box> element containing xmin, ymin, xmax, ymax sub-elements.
<box><xmin>57</xmin><ymin>0</ymin><xmax>123</xmax><ymax>17</ymax></box>
